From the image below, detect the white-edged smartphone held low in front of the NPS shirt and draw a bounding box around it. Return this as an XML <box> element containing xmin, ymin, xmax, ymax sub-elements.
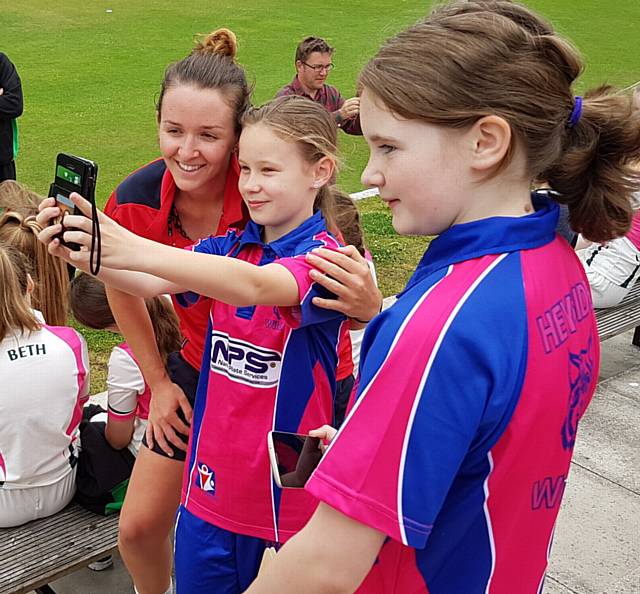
<box><xmin>267</xmin><ymin>431</ymin><xmax>323</xmax><ymax>489</ymax></box>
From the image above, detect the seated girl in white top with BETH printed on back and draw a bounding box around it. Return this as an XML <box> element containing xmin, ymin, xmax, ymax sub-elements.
<box><xmin>0</xmin><ymin>244</ymin><xmax>89</xmax><ymax>528</ymax></box>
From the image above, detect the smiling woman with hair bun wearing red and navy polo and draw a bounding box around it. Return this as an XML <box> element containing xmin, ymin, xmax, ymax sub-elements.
<box><xmin>100</xmin><ymin>29</ymin><xmax>251</xmax><ymax>594</ymax></box>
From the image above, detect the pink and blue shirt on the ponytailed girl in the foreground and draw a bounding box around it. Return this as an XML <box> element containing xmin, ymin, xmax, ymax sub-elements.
<box><xmin>306</xmin><ymin>199</ymin><xmax>599</xmax><ymax>594</ymax></box>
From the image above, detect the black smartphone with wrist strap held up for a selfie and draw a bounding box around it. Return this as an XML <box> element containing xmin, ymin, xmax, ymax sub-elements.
<box><xmin>49</xmin><ymin>153</ymin><xmax>98</xmax><ymax>249</ymax></box>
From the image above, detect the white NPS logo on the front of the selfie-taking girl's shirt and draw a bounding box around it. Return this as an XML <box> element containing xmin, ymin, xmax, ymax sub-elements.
<box><xmin>211</xmin><ymin>331</ymin><xmax>282</xmax><ymax>388</ymax></box>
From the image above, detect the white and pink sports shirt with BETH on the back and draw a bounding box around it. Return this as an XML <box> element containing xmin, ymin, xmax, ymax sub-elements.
<box><xmin>0</xmin><ymin>312</ymin><xmax>89</xmax><ymax>489</ymax></box>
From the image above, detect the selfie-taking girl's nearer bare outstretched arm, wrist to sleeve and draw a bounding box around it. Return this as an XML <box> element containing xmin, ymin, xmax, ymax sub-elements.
<box><xmin>134</xmin><ymin>244</ymin><xmax>299</xmax><ymax>307</ymax></box>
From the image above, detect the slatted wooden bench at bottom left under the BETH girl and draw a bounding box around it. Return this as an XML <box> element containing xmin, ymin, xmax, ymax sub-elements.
<box><xmin>0</xmin><ymin>503</ymin><xmax>118</xmax><ymax>594</ymax></box>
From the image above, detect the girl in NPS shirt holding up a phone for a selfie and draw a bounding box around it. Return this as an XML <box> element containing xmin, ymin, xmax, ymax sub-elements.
<box><xmin>40</xmin><ymin>97</ymin><xmax>348</xmax><ymax>593</ymax></box>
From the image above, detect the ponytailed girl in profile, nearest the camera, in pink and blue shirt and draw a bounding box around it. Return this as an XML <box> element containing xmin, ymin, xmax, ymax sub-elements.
<box><xmin>240</xmin><ymin>0</ymin><xmax>640</xmax><ymax>594</ymax></box>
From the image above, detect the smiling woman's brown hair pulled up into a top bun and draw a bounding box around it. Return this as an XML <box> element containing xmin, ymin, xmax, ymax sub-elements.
<box><xmin>156</xmin><ymin>28</ymin><xmax>252</xmax><ymax>134</ymax></box>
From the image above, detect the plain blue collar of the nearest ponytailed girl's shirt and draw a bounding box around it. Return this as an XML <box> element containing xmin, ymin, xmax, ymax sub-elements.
<box><xmin>405</xmin><ymin>192</ymin><xmax>560</xmax><ymax>290</ymax></box>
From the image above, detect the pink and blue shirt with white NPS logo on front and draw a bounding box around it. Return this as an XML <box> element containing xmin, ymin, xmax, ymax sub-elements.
<box><xmin>178</xmin><ymin>212</ymin><xmax>347</xmax><ymax>542</ymax></box>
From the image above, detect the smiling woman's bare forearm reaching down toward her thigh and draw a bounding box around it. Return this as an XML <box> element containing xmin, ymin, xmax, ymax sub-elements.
<box><xmin>106</xmin><ymin>286</ymin><xmax>172</xmax><ymax>390</ymax></box>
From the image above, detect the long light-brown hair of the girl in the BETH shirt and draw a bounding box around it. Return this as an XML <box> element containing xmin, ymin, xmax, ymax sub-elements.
<box><xmin>0</xmin><ymin>243</ymin><xmax>40</xmax><ymax>340</ymax></box>
